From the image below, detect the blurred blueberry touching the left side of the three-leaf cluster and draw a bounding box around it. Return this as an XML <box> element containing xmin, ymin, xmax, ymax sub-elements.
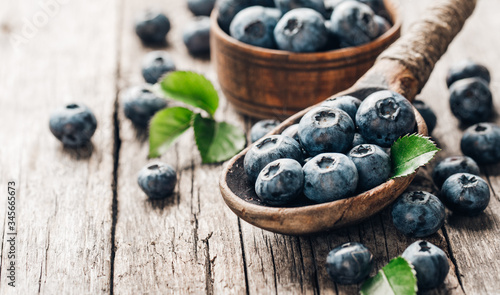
<box><xmin>122</xmin><ymin>85</ymin><xmax>167</xmax><ymax>128</ymax></box>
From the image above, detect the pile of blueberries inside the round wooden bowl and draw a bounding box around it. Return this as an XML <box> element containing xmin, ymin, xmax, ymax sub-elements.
<box><xmin>221</xmin><ymin>0</ymin><xmax>391</xmax><ymax>52</ymax></box>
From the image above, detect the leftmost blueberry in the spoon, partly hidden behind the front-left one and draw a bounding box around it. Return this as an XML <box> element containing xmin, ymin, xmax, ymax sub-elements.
<box><xmin>243</xmin><ymin>135</ymin><xmax>303</xmax><ymax>182</ymax></box>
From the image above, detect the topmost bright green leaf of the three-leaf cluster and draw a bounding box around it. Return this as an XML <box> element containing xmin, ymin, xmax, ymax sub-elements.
<box><xmin>160</xmin><ymin>71</ymin><xmax>219</xmax><ymax>116</ymax></box>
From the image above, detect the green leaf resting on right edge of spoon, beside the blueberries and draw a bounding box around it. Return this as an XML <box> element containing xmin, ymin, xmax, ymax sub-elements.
<box><xmin>391</xmin><ymin>134</ymin><xmax>440</xmax><ymax>178</ymax></box>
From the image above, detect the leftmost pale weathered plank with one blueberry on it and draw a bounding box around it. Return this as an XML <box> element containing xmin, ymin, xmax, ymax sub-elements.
<box><xmin>0</xmin><ymin>0</ymin><xmax>117</xmax><ymax>294</ymax></box>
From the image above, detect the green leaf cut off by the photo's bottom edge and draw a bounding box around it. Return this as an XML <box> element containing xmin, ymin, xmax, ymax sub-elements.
<box><xmin>360</xmin><ymin>257</ymin><xmax>418</xmax><ymax>295</ymax></box>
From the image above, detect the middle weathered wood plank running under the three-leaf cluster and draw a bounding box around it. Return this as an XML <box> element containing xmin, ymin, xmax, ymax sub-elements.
<box><xmin>113</xmin><ymin>0</ymin><xmax>246</xmax><ymax>294</ymax></box>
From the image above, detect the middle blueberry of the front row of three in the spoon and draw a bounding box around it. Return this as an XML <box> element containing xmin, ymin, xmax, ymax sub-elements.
<box><xmin>302</xmin><ymin>153</ymin><xmax>358</xmax><ymax>203</ymax></box>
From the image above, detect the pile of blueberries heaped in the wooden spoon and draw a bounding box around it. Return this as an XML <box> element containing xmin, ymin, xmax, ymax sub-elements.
<box><xmin>244</xmin><ymin>90</ymin><xmax>416</xmax><ymax>206</ymax></box>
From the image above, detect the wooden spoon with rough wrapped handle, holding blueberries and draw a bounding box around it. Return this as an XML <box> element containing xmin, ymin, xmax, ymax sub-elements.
<box><xmin>219</xmin><ymin>0</ymin><xmax>476</xmax><ymax>235</ymax></box>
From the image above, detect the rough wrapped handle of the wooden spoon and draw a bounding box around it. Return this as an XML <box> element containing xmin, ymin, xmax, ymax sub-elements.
<box><xmin>356</xmin><ymin>0</ymin><xmax>477</xmax><ymax>101</ymax></box>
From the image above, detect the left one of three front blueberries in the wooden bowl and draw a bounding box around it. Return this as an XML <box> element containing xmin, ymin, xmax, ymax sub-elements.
<box><xmin>229</xmin><ymin>6</ymin><xmax>280</xmax><ymax>48</ymax></box>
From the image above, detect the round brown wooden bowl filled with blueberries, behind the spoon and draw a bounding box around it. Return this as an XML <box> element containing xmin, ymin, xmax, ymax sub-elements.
<box><xmin>210</xmin><ymin>0</ymin><xmax>401</xmax><ymax>119</ymax></box>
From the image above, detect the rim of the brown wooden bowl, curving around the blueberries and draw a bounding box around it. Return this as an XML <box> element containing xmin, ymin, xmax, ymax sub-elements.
<box><xmin>210</xmin><ymin>0</ymin><xmax>402</xmax><ymax>61</ymax></box>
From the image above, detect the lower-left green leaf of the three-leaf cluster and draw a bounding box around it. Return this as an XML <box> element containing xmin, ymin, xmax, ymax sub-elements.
<box><xmin>149</xmin><ymin>107</ymin><xmax>193</xmax><ymax>158</ymax></box>
